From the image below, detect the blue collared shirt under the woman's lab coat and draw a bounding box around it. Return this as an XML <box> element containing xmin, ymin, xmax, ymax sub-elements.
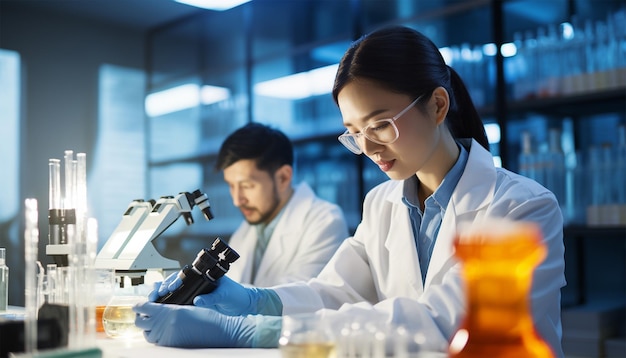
<box><xmin>402</xmin><ymin>143</ymin><xmax>469</xmax><ymax>282</ymax></box>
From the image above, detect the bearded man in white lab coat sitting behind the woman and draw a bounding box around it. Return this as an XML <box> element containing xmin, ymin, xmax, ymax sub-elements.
<box><xmin>210</xmin><ymin>123</ymin><xmax>348</xmax><ymax>287</ymax></box>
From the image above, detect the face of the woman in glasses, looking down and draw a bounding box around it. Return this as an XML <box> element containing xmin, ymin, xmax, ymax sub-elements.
<box><xmin>337</xmin><ymin>79</ymin><xmax>445</xmax><ymax>180</ymax></box>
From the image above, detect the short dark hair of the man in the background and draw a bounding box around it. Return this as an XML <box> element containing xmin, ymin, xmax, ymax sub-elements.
<box><xmin>215</xmin><ymin>123</ymin><xmax>293</xmax><ymax>174</ymax></box>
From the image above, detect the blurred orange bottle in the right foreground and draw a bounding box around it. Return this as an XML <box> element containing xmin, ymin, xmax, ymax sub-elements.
<box><xmin>448</xmin><ymin>222</ymin><xmax>554</xmax><ymax>358</ymax></box>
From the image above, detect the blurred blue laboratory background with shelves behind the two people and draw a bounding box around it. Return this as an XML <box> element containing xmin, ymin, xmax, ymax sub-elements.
<box><xmin>0</xmin><ymin>0</ymin><xmax>626</xmax><ymax>356</ymax></box>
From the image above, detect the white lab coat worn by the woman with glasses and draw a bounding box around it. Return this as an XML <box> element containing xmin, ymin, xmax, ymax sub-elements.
<box><xmin>275</xmin><ymin>140</ymin><xmax>565</xmax><ymax>357</ymax></box>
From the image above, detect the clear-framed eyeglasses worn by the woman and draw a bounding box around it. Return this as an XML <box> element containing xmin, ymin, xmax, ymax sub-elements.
<box><xmin>337</xmin><ymin>95</ymin><xmax>423</xmax><ymax>154</ymax></box>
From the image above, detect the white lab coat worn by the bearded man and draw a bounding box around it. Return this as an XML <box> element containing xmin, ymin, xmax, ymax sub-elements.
<box><xmin>228</xmin><ymin>183</ymin><xmax>349</xmax><ymax>287</ymax></box>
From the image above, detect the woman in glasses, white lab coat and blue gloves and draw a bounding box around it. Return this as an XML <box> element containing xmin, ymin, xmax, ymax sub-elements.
<box><xmin>134</xmin><ymin>27</ymin><xmax>565</xmax><ymax>357</ymax></box>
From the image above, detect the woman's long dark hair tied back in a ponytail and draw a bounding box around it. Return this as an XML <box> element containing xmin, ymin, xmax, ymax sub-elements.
<box><xmin>333</xmin><ymin>26</ymin><xmax>489</xmax><ymax>150</ymax></box>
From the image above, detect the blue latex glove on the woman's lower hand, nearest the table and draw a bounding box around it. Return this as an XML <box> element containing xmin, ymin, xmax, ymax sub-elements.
<box><xmin>133</xmin><ymin>302</ymin><xmax>256</xmax><ymax>348</ymax></box>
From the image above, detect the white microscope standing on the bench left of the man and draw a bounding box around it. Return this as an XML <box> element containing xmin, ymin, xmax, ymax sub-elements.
<box><xmin>95</xmin><ymin>190</ymin><xmax>213</xmax><ymax>286</ymax></box>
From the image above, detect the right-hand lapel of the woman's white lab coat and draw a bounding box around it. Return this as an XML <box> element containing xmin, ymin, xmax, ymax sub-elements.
<box><xmin>425</xmin><ymin>140</ymin><xmax>496</xmax><ymax>287</ymax></box>
